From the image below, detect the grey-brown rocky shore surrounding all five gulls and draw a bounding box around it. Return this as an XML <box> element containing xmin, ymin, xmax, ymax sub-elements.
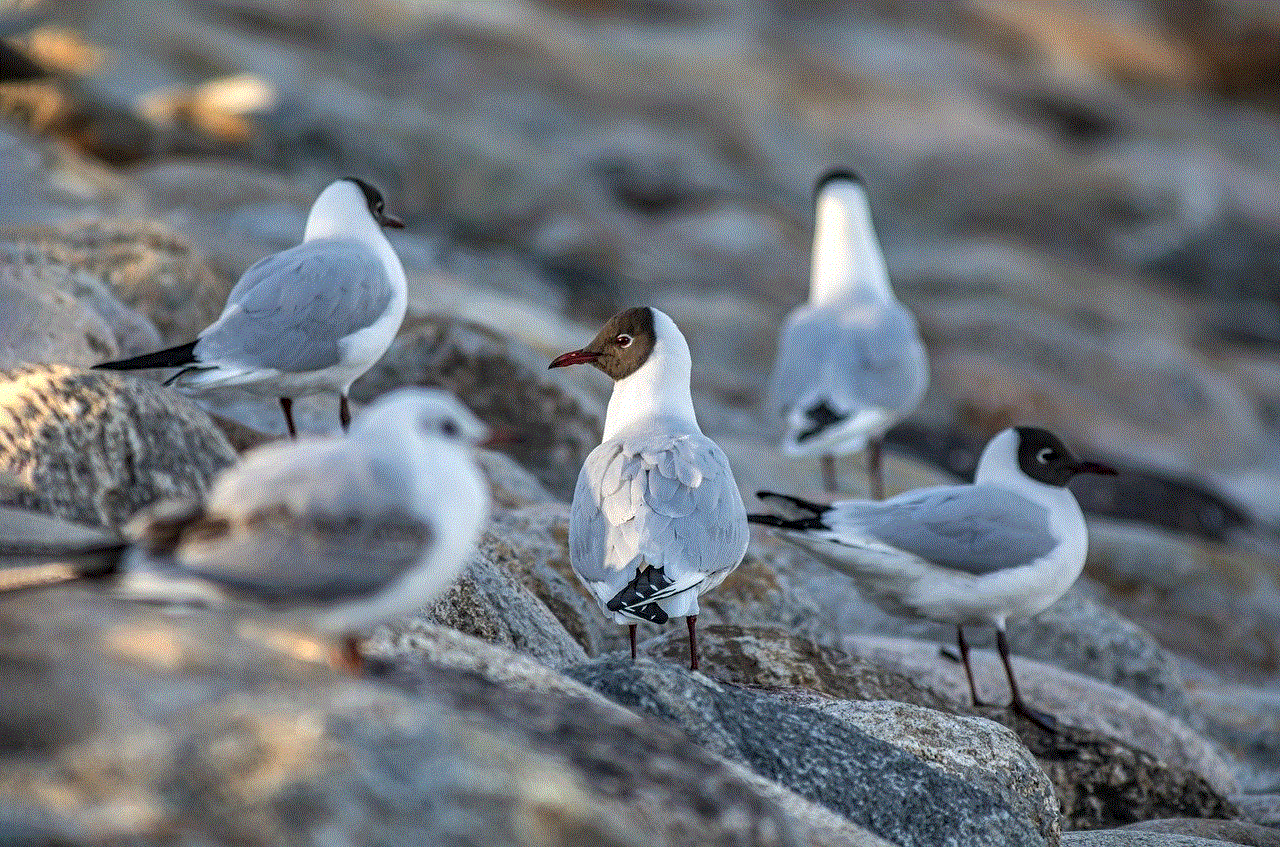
<box><xmin>0</xmin><ymin>0</ymin><xmax>1280</xmax><ymax>847</ymax></box>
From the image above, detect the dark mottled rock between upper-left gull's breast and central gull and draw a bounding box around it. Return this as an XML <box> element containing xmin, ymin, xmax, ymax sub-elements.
<box><xmin>352</xmin><ymin>316</ymin><xmax>600</xmax><ymax>499</ymax></box>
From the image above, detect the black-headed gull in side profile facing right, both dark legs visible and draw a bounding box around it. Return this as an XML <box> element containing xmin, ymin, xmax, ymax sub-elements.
<box><xmin>749</xmin><ymin>426</ymin><xmax>1115</xmax><ymax>731</ymax></box>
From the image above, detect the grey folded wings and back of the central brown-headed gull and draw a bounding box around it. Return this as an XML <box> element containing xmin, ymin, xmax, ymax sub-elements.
<box><xmin>570</xmin><ymin>432</ymin><xmax>749</xmax><ymax>589</ymax></box>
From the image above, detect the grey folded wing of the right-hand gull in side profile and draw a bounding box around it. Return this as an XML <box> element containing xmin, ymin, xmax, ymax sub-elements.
<box><xmin>828</xmin><ymin>485</ymin><xmax>1059</xmax><ymax>576</ymax></box>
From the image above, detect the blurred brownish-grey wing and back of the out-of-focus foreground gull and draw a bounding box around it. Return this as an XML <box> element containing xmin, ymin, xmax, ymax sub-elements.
<box><xmin>173</xmin><ymin>443</ymin><xmax>435</xmax><ymax>603</ymax></box>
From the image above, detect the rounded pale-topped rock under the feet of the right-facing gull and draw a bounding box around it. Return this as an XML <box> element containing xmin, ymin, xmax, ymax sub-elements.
<box><xmin>842</xmin><ymin>636</ymin><xmax>1238</xmax><ymax>829</ymax></box>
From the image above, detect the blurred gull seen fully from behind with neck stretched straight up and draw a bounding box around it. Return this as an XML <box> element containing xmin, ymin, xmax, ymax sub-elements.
<box><xmin>768</xmin><ymin>170</ymin><xmax>929</xmax><ymax>500</ymax></box>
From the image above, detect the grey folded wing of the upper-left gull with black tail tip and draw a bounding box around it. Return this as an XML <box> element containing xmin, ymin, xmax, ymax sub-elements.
<box><xmin>196</xmin><ymin>238</ymin><xmax>394</xmax><ymax>372</ymax></box>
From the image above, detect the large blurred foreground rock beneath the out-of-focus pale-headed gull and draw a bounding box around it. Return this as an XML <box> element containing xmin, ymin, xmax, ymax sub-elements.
<box><xmin>0</xmin><ymin>587</ymin><xmax>886</xmax><ymax>847</ymax></box>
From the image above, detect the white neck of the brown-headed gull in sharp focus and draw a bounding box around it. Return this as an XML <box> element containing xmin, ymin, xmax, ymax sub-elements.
<box><xmin>602</xmin><ymin>310</ymin><xmax>701</xmax><ymax>441</ymax></box>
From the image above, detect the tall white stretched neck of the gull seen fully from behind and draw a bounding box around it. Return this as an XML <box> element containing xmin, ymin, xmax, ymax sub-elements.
<box><xmin>809</xmin><ymin>182</ymin><xmax>893</xmax><ymax>305</ymax></box>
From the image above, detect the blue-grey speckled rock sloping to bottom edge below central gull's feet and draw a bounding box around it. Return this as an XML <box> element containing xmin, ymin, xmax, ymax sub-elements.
<box><xmin>567</xmin><ymin>658</ymin><xmax>1046</xmax><ymax>847</ymax></box>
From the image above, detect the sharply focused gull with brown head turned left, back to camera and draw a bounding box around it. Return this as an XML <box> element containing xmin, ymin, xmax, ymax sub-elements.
<box><xmin>550</xmin><ymin>307</ymin><xmax>750</xmax><ymax>670</ymax></box>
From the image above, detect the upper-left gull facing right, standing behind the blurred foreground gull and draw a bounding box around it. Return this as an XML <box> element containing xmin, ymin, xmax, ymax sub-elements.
<box><xmin>95</xmin><ymin>177</ymin><xmax>408</xmax><ymax>438</ymax></box>
